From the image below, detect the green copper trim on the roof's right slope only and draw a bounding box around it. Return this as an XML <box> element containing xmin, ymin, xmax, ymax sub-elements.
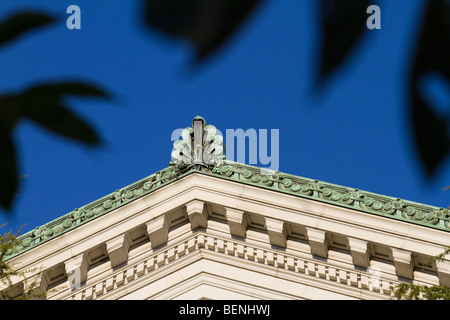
<box><xmin>212</xmin><ymin>163</ymin><xmax>450</xmax><ymax>232</ymax></box>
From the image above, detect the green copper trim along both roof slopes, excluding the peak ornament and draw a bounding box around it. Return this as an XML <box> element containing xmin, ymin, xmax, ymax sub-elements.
<box><xmin>6</xmin><ymin>161</ymin><xmax>450</xmax><ymax>259</ymax></box>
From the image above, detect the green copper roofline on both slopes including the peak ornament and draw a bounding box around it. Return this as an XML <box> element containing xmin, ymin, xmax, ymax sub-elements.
<box><xmin>6</xmin><ymin>116</ymin><xmax>450</xmax><ymax>259</ymax></box>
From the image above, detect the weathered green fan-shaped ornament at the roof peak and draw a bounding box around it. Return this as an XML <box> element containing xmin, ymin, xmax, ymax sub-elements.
<box><xmin>170</xmin><ymin>116</ymin><xmax>225</xmax><ymax>172</ymax></box>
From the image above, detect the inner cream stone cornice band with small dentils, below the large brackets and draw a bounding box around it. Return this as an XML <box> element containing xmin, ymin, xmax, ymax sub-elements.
<box><xmin>58</xmin><ymin>232</ymin><xmax>398</xmax><ymax>300</ymax></box>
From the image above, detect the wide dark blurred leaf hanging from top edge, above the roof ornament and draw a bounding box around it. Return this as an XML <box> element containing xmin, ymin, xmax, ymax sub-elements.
<box><xmin>145</xmin><ymin>0</ymin><xmax>261</xmax><ymax>61</ymax></box>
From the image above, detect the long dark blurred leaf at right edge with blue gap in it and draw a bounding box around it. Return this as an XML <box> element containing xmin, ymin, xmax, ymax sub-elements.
<box><xmin>409</xmin><ymin>0</ymin><xmax>450</xmax><ymax>176</ymax></box>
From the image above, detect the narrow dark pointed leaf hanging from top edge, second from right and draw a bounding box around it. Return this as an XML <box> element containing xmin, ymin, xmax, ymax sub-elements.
<box><xmin>319</xmin><ymin>0</ymin><xmax>369</xmax><ymax>81</ymax></box>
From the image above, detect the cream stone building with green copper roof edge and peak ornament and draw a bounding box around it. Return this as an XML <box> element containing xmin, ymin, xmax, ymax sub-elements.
<box><xmin>1</xmin><ymin>118</ymin><xmax>450</xmax><ymax>300</ymax></box>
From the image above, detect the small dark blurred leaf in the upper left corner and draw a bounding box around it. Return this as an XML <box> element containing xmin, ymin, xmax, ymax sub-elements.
<box><xmin>0</xmin><ymin>12</ymin><xmax>55</xmax><ymax>45</ymax></box>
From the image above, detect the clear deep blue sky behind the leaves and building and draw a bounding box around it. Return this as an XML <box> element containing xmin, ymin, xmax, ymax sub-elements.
<box><xmin>0</xmin><ymin>0</ymin><xmax>450</xmax><ymax>232</ymax></box>
